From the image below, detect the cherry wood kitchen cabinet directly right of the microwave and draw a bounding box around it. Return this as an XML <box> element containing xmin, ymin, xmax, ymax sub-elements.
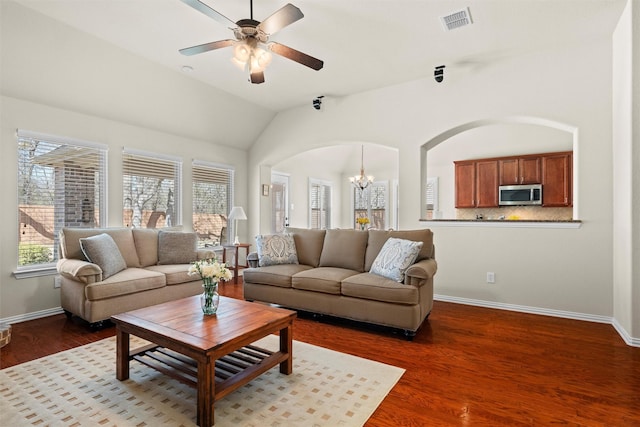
<box><xmin>542</xmin><ymin>151</ymin><xmax>573</xmax><ymax>207</ymax></box>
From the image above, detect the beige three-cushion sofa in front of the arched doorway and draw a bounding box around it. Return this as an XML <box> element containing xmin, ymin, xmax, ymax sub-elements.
<box><xmin>243</xmin><ymin>228</ymin><xmax>437</xmax><ymax>339</ymax></box>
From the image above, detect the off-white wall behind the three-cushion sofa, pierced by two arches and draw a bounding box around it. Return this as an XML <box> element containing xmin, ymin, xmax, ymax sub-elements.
<box><xmin>249</xmin><ymin>39</ymin><xmax>613</xmax><ymax>324</ymax></box>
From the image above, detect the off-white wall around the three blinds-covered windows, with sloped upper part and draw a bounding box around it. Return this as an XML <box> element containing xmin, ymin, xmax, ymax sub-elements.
<box><xmin>0</xmin><ymin>1</ymin><xmax>273</xmax><ymax>319</ymax></box>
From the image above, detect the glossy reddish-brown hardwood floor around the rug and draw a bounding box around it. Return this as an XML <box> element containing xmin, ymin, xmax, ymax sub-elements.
<box><xmin>0</xmin><ymin>283</ymin><xmax>640</xmax><ymax>427</ymax></box>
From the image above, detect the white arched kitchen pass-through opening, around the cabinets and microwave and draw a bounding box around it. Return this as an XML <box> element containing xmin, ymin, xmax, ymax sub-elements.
<box><xmin>421</xmin><ymin>116</ymin><xmax>578</xmax><ymax>220</ymax></box>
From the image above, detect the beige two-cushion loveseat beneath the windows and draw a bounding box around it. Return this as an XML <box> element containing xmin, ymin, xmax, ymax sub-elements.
<box><xmin>57</xmin><ymin>228</ymin><xmax>214</xmax><ymax>327</ymax></box>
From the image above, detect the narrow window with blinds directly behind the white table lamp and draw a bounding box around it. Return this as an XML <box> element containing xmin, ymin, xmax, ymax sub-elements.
<box><xmin>192</xmin><ymin>161</ymin><xmax>235</xmax><ymax>247</ymax></box>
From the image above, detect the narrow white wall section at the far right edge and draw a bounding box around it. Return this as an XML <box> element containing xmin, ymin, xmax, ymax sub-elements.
<box><xmin>612</xmin><ymin>2</ymin><xmax>640</xmax><ymax>337</ymax></box>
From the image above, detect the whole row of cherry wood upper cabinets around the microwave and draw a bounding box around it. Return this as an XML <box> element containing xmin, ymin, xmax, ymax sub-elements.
<box><xmin>454</xmin><ymin>151</ymin><xmax>573</xmax><ymax>209</ymax></box>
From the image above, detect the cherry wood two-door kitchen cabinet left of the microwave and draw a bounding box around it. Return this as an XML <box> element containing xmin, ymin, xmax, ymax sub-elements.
<box><xmin>454</xmin><ymin>160</ymin><xmax>498</xmax><ymax>208</ymax></box>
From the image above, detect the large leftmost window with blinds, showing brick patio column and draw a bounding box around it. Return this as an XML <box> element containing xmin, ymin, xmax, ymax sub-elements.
<box><xmin>18</xmin><ymin>130</ymin><xmax>107</xmax><ymax>270</ymax></box>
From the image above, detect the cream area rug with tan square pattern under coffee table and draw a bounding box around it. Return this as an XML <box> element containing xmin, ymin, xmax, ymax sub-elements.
<box><xmin>0</xmin><ymin>335</ymin><xmax>404</xmax><ymax>427</ymax></box>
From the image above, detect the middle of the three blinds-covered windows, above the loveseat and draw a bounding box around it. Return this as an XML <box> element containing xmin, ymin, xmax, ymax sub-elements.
<box><xmin>122</xmin><ymin>150</ymin><xmax>182</xmax><ymax>228</ymax></box>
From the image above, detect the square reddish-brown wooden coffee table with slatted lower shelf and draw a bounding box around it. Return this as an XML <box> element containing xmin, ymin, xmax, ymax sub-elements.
<box><xmin>111</xmin><ymin>296</ymin><xmax>296</xmax><ymax>427</ymax></box>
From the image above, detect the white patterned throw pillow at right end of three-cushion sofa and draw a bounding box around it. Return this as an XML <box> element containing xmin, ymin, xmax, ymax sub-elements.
<box><xmin>370</xmin><ymin>237</ymin><xmax>423</xmax><ymax>282</ymax></box>
